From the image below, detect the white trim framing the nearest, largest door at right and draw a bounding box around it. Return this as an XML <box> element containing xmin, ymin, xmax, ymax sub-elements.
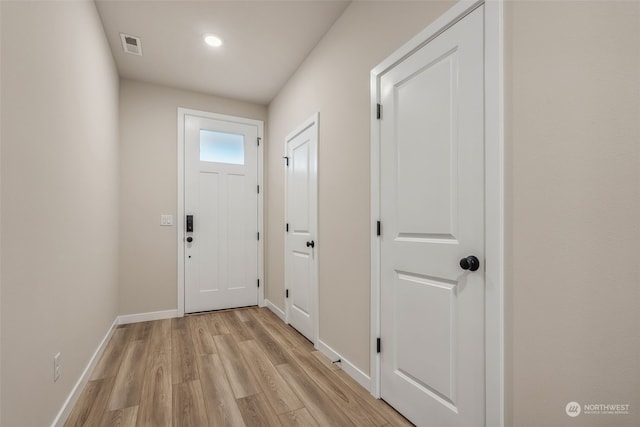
<box><xmin>370</xmin><ymin>0</ymin><xmax>504</xmax><ymax>427</ymax></box>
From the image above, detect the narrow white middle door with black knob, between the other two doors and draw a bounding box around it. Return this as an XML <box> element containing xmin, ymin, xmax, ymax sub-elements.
<box><xmin>285</xmin><ymin>115</ymin><xmax>318</xmax><ymax>344</ymax></box>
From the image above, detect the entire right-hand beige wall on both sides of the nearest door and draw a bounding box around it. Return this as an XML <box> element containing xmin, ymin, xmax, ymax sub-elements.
<box><xmin>267</xmin><ymin>2</ymin><xmax>640</xmax><ymax>427</ymax></box>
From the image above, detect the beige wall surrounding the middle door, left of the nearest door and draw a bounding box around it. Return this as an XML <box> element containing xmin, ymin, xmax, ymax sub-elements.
<box><xmin>265</xmin><ymin>1</ymin><xmax>452</xmax><ymax>373</ymax></box>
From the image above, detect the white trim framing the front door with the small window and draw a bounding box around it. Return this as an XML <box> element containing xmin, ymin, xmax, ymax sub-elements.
<box><xmin>176</xmin><ymin>107</ymin><xmax>265</xmax><ymax>317</ymax></box>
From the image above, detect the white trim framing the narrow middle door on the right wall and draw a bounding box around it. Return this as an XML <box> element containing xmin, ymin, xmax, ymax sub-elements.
<box><xmin>283</xmin><ymin>112</ymin><xmax>320</xmax><ymax>348</ymax></box>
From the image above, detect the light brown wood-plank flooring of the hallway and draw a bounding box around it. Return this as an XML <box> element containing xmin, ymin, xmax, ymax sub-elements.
<box><xmin>65</xmin><ymin>307</ymin><xmax>411</xmax><ymax>427</ymax></box>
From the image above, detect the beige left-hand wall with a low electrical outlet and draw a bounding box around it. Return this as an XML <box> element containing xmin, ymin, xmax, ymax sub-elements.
<box><xmin>0</xmin><ymin>1</ymin><xmax>118</xmax><ymax>427</ymax></box>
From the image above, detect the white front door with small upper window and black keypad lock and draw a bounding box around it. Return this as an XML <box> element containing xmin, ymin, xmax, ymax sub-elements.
<box><xmin>184</xmin><ymin>115</ymin><xmax>259</xmax><ymax>313</ymax></box>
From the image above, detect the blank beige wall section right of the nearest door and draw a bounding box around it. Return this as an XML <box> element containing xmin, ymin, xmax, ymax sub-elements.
<box><xmin>505</xmin><ymin>1</ymin><xmax>640</xmax><ymax>427</ymax></box>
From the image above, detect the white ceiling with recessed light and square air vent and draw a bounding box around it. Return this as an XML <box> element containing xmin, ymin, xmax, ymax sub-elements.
<box><xmin>96</xmin><ymin>0</ymin><xmax>349</xmax><ymax>104</ymax></box>
